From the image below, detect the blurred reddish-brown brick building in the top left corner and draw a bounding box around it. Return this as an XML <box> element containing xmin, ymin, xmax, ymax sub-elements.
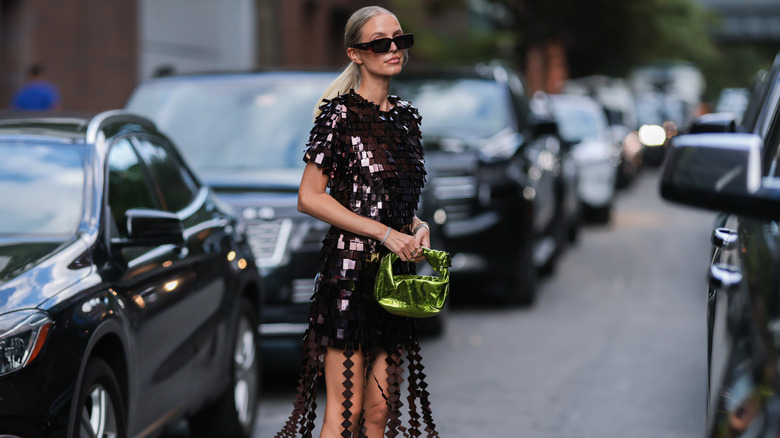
<box><xmin>0</xmin><ymin>0</ymin><xmax>138</xmax><ymax>111</ymax></box>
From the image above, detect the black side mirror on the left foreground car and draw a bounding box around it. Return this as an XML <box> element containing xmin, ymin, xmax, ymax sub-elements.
<box><xmin>111</xmin><ymin>208</ymin><xmax>184</xmax><ymax>247</ymax></box>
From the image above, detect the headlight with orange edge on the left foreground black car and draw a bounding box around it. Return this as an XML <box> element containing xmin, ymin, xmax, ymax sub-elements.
<box><xmin>0</xmin><ymin>310</ymin><xmax>52</xmax><ymax>376</ymax></box>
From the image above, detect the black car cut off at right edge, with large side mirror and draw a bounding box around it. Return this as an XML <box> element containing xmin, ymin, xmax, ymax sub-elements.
<box><xmin>661</xmin><ymin>55</ymin><xmax>780</xmax><ymax>437</ymax></box>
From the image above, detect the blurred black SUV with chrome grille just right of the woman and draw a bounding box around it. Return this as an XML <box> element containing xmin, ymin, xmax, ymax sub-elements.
<box><xmin>391</xmin><ymin>65</ymin><xmax>579</xmax><ymax>303</ymax></box>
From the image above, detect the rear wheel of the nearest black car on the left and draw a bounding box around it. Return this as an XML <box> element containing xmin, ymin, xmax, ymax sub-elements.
<box><xmin>190</xmin><ymin>300</ymin><xmax>260</xmax><ymax>438</ymax></box>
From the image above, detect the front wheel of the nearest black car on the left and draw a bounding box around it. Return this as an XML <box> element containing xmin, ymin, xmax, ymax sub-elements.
<box><xmin>72</xmin><ymin>357</ymin><xmax>127</xmax><ymax>438</ymax></box>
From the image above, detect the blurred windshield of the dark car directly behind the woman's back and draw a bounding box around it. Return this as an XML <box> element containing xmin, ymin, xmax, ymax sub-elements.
<box><xmin>128</xmin><ymin>77</ymin><xmax>331</xmax><ymax>171</ymax></box>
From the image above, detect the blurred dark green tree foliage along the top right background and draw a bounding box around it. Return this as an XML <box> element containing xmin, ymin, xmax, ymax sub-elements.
<box><xmin>390</xmin><ymin>0</ymin><xmax>777</xmax><ymax>99</ymax></box>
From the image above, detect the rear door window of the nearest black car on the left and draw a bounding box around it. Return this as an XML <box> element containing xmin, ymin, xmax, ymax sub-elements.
<box><xmin>133</xmin><ymin>138</ymin><xmax>198</xmax><ymax>211</ymax></box>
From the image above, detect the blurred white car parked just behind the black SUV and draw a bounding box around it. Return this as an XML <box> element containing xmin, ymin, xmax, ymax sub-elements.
<box><xmin>548</xmin><ymin>94</ymin><xmax>621</xmax><ymax>223</ymax></box>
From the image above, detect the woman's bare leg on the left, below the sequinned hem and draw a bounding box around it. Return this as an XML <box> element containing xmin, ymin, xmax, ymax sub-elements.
<box><xmin>320</xmin><ymin>347</ymin><xmax>366</xmax><ymax>438</ymax></box>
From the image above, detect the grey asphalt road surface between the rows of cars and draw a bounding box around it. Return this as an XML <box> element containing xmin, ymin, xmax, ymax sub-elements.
<box><xmin>176</xmin><ymin>166</ymin><xmax>714</xmax><ymax>438</ymax></box>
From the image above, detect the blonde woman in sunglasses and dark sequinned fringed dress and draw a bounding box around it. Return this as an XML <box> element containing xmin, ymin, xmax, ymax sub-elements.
<box><xmin>276</xmin><ymin>6</ymin><xmax>438</xmax><ymax>438</ymax></box>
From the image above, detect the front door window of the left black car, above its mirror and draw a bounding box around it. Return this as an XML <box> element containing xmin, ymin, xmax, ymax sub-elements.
<box><xmin>108</xmin><ymin>138</ymin><xmax>156</xmax><ymax>237</ymax></box>
